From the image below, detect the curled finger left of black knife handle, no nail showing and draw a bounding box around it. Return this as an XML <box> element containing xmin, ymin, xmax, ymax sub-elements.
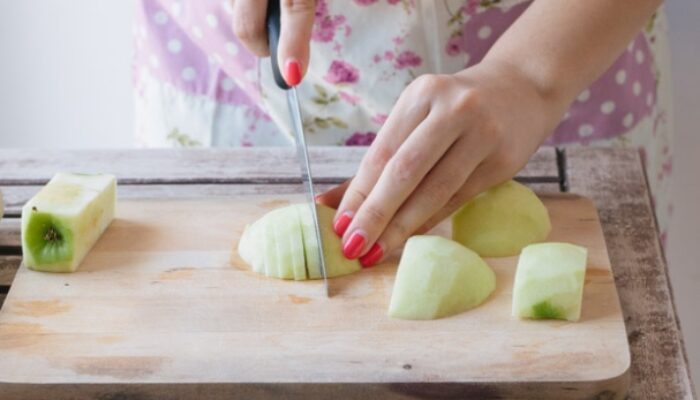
<box><xmin>232</xmin><ymin>0</ymin><xmax>270</xmax><ymax>57</ymax></box>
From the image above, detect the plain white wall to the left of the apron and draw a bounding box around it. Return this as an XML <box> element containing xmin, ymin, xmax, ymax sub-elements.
<box><xmin>0</xmin><ymin>0</ymin><xmax>134</xmax><ymax>148</ymax></box>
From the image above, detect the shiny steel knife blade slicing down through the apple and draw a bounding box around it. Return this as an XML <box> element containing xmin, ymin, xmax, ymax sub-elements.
<box><xmin>287</xmin><ymin>87</ymin><xmax>330</xmax><ymax>296</ymax></box>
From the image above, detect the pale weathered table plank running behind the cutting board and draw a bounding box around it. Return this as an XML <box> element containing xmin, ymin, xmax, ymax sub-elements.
<box><xmin>0</xmin><ymin>147</ymin><xmax>557</xmax><ymax>186</ymax></box>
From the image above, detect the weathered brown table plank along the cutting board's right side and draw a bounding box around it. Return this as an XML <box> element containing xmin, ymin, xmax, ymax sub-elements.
<box><xmin>570</xmin><ymin>149</ymin><xmax>695</xmax><ymax>399</ymax></box>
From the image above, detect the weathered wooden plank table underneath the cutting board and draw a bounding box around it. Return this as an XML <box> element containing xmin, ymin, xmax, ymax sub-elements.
<box><xmin>0</xmin><ymin>147</ymin><xmax>695</xmax><ymax>400</ymax></box>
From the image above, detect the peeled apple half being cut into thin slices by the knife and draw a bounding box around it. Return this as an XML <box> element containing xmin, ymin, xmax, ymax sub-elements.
<box><xmin>238</xmin><ymin>204</ymin><xmax>362</xmax><ymax>280</ymax></box>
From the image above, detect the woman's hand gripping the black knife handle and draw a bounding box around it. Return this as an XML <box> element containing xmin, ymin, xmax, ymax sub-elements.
<box><xmin>229</xmin><ymin>0</ymin><xmax>316</xmax><ymax>86</ymax></box>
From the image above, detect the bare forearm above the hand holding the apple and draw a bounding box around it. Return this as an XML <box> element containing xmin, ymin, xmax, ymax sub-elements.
<box><xmin>484</xmin><ymin>0</ymin><xmax>662</xmax><ymax>108</ymax></box>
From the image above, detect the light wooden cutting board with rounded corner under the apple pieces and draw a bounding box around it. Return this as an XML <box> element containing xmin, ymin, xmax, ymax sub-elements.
<box><xmin>0</xmin><ymin>195</ymin><xmax>630</xmax><ymax>398</ymax></box>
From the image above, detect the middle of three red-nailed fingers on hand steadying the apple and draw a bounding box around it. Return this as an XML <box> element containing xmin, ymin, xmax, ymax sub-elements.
<box><xmin>343</xmin><ymin>116</ymin><xmax>459</xmax><ymax>259</ymax></box>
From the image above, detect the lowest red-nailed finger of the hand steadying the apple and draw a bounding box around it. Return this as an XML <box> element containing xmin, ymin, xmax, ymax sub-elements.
<box><xmin>360</xmin><ymin>135</ymin><xmax>486</xmax><ymax>267</ymax></box>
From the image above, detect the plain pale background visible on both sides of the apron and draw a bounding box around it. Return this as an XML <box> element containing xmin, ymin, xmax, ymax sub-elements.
<box><xmin>0</xmin><ymin>0</ymin><xmax>700</xmax><ymax>384</ymax></box>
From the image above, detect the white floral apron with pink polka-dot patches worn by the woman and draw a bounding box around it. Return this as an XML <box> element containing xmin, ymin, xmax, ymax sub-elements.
<box><xmin>133</xmin><ymin>0</ymin><xmax>673</xmax><ymax>243</ymax></box>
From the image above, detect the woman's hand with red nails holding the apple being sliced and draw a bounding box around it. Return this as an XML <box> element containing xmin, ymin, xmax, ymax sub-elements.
<box><xmin>318</xmin><ymin>62</ymin><xmax>568</xmax><ymax>266</ymax></box>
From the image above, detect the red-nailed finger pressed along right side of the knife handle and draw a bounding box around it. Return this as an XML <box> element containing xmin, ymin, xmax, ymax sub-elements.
<box><xmin>274</xmin><ymin>0</ymin><xmax>316</xmax><ymax>86</ymax></box>
